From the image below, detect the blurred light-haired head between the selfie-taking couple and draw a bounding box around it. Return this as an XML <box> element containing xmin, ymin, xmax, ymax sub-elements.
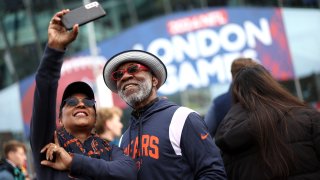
<box><xmin>95</xmin><ymin>107</ymin><xmax>123</xmax><ymax>142</ymax></box>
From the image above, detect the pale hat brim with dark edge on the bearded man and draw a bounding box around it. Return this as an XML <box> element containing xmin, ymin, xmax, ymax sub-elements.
<box><xmin>103</xmin><ymin>50</ymin><xmax>167</xmax><ymax>93</ymax></box>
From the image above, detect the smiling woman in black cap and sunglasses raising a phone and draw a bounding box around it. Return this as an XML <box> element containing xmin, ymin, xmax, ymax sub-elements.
<box><xmin>30</xmin><ymin>10</ymin><xmax>136</xmax><ymax>180</ymax></box>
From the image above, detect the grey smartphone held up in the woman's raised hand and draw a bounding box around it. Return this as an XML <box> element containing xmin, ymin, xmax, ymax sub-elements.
<box><xmin>62</xmin><ymin>1</ymin><xmax>106</xmax><ymax>30</ymax></box>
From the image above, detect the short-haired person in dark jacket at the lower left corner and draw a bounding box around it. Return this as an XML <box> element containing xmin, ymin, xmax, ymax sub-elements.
<box><xmin>0</xmin><ymin>140</ymin><xmax>27</xmax><ymax>180</ymax></box>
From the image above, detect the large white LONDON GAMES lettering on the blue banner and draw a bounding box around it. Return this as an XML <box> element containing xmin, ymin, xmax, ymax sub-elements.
<box><xmin>134</xmin><ymin>18</ymin><xmax>272</xmax><ymax>94</ymax></box>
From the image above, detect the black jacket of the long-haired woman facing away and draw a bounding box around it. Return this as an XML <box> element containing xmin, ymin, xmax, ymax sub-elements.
<box><xmin>216</xmin><ymin>104</ymin><xmax>320</xmax><ymax>180</ymax></box>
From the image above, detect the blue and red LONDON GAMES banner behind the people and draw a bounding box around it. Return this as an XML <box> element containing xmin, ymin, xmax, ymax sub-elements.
<box><xmin>81</xmin><ymin>8</ymin><xmax>294</xmax><ymax>95</ymax></box>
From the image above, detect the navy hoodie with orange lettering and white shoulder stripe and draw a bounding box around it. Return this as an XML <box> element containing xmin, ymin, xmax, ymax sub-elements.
<box><xmin>120</xmin><ymin>99</ymin><xmax>226</xmax><ymax>180</ymax></box>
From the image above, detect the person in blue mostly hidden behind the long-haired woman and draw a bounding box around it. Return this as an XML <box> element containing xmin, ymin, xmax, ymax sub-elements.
<box><xmin>204</xmin><ymin>57</ymin><xmax>257</xmax><ymax>137</ymax></box>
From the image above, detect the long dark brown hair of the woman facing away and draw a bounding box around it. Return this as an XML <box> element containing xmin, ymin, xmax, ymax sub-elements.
<box><xmin>232</xmin><ymin>64</ymin><xmax>305</xmax><ymax>177</ymax></box>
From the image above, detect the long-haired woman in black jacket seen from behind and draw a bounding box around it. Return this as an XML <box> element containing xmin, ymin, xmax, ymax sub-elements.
<box><xmin>215</xmin><ymin>65</ymin><xmax>320</xmax><ymax>180</ymax></box>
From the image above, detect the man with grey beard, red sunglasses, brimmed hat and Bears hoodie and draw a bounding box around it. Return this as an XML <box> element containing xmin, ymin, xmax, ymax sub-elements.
<box><xmin>103</xmin><ymin>50</ymin><xmax>226</xmax><ymax>180</ymax></box>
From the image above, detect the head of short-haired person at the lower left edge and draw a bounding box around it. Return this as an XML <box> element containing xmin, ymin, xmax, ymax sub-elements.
<box><xmin>3</xmin><ymin>140</ymin><xmax>27</xmax><ymax>167</ymax></box>
